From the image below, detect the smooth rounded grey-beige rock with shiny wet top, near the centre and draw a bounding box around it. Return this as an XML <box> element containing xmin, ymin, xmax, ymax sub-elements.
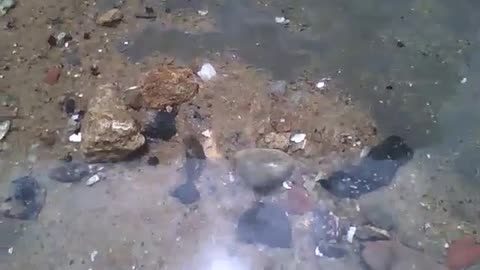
<box><xmin>233</xmin><ymin>148</ymin><xmax>295</xmax><ymax>192</ymax></box>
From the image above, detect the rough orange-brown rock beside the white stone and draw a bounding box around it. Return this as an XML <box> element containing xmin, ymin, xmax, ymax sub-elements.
<box><xmin>140</xmin><ymin>66</ymin><xmax>199</xmax><ymax>109</ymax></box>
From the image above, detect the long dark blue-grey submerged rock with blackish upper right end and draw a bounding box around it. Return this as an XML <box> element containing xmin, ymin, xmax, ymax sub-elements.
<box><xmin>320</xmin><ymin>136</ymin><xmax>413</xmax><ymax>198</ymax></box>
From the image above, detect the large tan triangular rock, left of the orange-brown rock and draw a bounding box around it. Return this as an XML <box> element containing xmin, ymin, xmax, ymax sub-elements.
<box><xmin>80</xmin><ymin>84</ymin><xmax>145</xmax><ymax>162</ymax></box>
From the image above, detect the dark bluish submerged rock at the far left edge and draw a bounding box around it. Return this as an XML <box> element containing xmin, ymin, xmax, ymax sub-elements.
<box><xmin>3</xmin><ymin>176</ymin><xmax>47</xmax><ymax>220</ymax></box>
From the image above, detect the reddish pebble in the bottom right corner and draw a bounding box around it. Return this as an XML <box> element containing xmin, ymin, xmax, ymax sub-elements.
<box><xmin>447</xmin><ymin>236</ymin><xmax>480</xmax><ymax>270</ymax></box>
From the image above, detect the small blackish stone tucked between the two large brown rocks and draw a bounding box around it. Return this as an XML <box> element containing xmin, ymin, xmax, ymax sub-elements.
<box><xmin>144</xmin><ymin>112</ymin><xmax>177</xmax><ymax>141</ymax></box>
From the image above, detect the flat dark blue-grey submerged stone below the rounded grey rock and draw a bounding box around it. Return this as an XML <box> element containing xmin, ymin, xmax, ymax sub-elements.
<box><xmin>236</xmin><ymin>203</ymin><xmax>292</xmax><ymax>248</ymax></box>
